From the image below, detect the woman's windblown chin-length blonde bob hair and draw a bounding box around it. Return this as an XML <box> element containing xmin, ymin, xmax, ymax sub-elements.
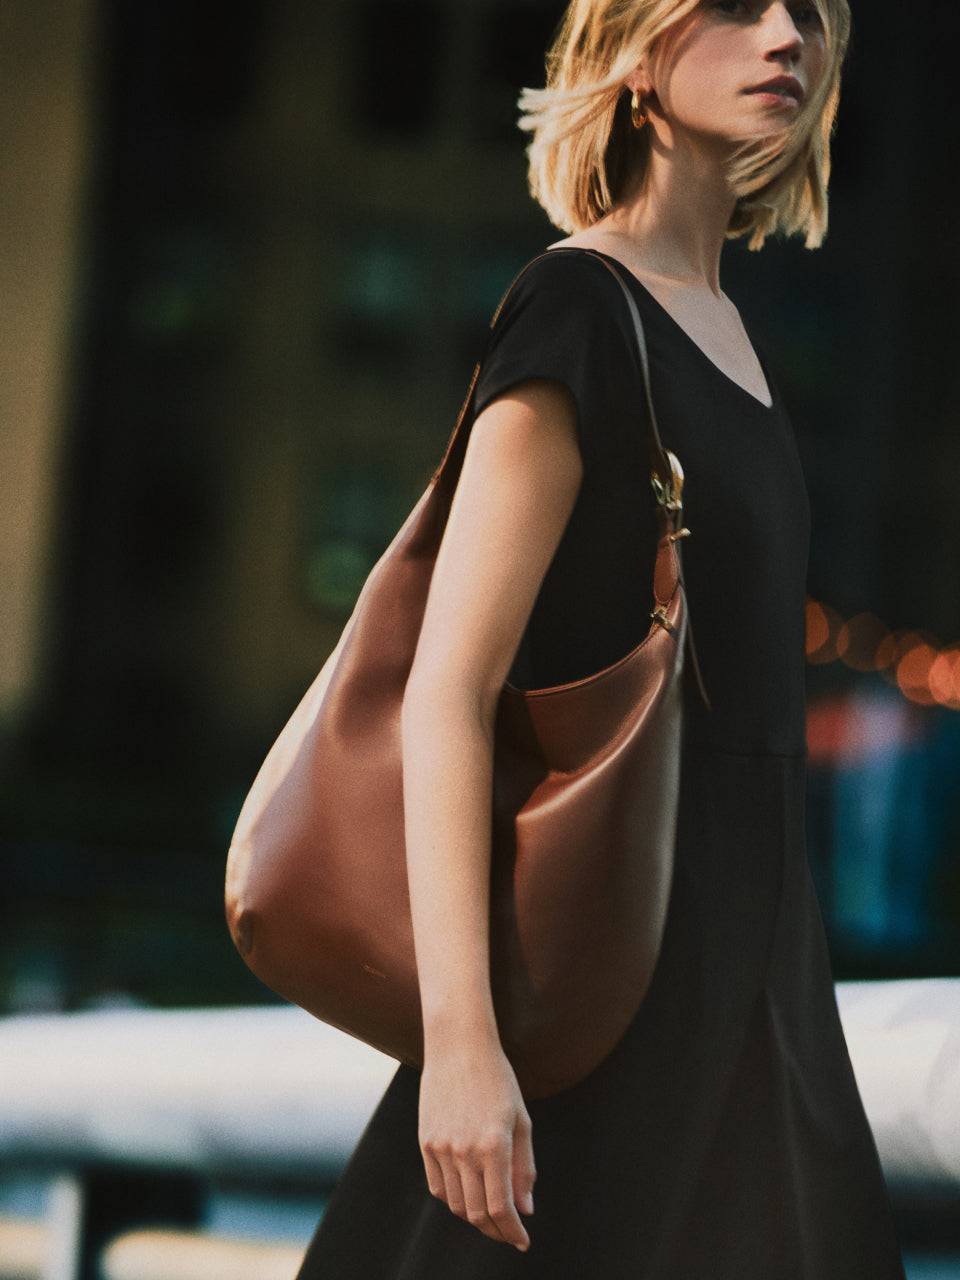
<box><xmin>520</xmin><ymin>0</ymin><xmax>850</xmax><ymax>248</ymax></box>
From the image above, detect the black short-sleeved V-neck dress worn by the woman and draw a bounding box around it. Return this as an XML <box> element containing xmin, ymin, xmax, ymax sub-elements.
<box><xmin>301</xmin><ymin>250</ymin><xmax>904</xmax><ymax>1280</ymax></box>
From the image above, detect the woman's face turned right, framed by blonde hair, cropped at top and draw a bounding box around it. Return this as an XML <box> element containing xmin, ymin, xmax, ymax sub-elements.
<box><xmin>648</xmin><ymin>0</ymin><xmax>827</xmax><ymax>142</ymax></box>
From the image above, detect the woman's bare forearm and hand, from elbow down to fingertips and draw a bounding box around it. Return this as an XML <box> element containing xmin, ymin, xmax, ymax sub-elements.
<box><xmin>403</xmin><ymin>666</ymin><xmax>536</xmax><ymax>1251</ymax></box>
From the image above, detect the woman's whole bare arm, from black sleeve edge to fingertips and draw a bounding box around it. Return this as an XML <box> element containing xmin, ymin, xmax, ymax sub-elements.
<box><xmin>403</xmin><ymin>381</ymin><xmax>582</xmax><ymax>1249</ymax></box>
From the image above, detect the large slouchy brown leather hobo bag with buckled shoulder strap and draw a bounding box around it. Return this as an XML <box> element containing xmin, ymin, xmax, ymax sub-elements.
<box><xmin>227</xmin><ymin>251</ymin><xmax>705</xmax><ymax>1098</ymax></box>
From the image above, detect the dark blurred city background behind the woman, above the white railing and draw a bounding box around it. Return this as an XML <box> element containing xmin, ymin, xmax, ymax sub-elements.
<box><xmin>0</xmin><ymin>0</ymin><xmax>960</xmax><ymax>1269</ymax></box>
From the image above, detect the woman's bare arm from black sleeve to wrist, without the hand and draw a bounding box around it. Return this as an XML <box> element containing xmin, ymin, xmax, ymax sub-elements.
<box><xmin>402</xmin><ymin>383</ymin><xmax>582</xmax><ymax>1051</ymax></box>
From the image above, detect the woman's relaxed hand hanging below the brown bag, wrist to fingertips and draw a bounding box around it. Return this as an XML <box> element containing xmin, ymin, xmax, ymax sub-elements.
<box><xmin>420</xmin><ymin>1044</ymin><xmax>536</xmax><ymax>1252</ymax></box>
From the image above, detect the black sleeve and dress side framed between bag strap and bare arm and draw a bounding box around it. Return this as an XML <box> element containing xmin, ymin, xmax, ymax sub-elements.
<box><xmin>474</xmin><ymin>250</ymin><xmax>657</xmax><ymax>689</ymax></box>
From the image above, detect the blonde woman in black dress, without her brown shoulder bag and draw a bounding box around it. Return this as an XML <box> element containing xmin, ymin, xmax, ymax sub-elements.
<box><xmin>301</xmin><ymin>0</ymin><xmax>904</xmax><ymax>1280</ymax></box>
